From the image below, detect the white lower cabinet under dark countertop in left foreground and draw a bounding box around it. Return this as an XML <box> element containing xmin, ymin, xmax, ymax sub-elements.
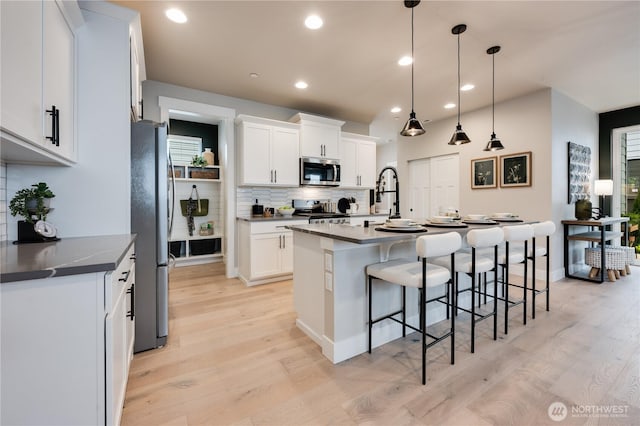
<box><xmin>0</xmin><ymin>246</ymin><xmax>135</xmax><ymax>425</ymax></box>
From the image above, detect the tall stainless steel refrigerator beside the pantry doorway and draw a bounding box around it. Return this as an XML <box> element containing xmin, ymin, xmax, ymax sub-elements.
<box><xmin>131</xmin><ymin>120</ymin><xmax>173</xmax><ymax>352</ymax></box>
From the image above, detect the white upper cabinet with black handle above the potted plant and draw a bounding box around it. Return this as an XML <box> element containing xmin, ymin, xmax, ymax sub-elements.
<box><xmin>0</xmin><ymin>1</ymin><xmax>82</xmax><ymax>165</ymax></box>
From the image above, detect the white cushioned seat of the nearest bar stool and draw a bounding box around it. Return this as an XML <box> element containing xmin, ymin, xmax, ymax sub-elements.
<box><xmin>367</xmin><ymin>256</ymin><xmax>451</xmax><ymax>288</ymax></box>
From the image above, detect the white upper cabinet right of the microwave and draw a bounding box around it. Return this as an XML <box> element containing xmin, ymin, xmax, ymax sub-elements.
<box><xmin>340</xmin><ymin>132</ymin><xmax>377</xmax><ymax>188</ymax></box>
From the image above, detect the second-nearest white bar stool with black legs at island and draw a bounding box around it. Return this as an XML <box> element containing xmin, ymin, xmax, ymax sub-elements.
<box><xmin>431</xmin><ymin>227</ymin><xmax>504</xmax><ymax>353</ymax></box>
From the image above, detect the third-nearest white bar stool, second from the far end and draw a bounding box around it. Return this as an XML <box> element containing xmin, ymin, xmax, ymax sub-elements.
<box><xmin>498</xmin><ymin>225</ymin><xmax>533</xmax><ymax>334</ymax></box>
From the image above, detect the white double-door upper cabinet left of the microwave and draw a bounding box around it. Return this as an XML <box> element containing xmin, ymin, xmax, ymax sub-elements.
<box><xmin>238</xmin><ymin>115</ymin><xmax>300</xmax><ymax>186</ymax></box>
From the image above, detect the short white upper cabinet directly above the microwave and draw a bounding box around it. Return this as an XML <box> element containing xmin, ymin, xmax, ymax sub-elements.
<box><xmin>289</xmin><ymin>113</ymin><xmax>344</xmax><ymax>159</ymax></box>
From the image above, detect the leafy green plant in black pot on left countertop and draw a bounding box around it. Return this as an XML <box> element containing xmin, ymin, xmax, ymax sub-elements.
<box><xmin>9</xmin><ymin>182</ymin><xmax>55</xmax><ymax>241</ymax></box>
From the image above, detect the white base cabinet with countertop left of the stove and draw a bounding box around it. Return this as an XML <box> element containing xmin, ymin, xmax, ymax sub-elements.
<box><xmin>238</xmin><ymin>219</ymin><xmax>308</xmax><ymax>285</ymax></box>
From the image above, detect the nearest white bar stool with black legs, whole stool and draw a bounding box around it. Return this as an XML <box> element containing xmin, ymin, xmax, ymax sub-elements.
<box><xmin>366</xmin><ymin>232</ymin><xmax>462</xmax><ymax>385</ymax></box>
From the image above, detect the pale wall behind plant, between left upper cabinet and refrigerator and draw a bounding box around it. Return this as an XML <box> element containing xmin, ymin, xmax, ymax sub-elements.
<box><xmin>7</xmin><ymin>5</ymin><xmax>131</xmax><ymax>239</ymax></box>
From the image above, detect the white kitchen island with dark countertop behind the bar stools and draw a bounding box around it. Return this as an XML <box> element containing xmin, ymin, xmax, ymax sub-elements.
<box><xmin>288</xmin><ymin>224</ymin><xmax>470</xmax><ymax>363</ymax></box>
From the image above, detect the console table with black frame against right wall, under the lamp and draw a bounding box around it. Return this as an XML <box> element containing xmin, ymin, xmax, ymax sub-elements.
<box><xmin>561</xmin><ymin>217</ymin><xmax>629</xmax><ymax>283</ymax></box>
